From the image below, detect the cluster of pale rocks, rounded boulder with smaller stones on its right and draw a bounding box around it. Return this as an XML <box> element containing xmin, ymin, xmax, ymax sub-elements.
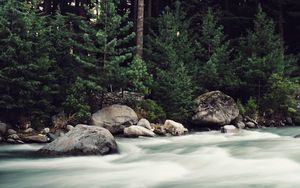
<box><xmin>92</xmin><ymin>104</ymin><xmax>188</xmax><ymax>137</ymax></box>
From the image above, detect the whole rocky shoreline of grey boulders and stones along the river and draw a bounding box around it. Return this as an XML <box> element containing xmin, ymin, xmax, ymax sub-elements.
<box><xmin>0</xmin><ymin>91</ymin><xmax>298</xmax><ymax>155</ymax></box>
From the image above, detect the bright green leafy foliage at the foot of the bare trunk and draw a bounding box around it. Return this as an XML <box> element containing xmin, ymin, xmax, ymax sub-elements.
<box><xmin>124</xmin><ymin>57</ymin><xmax>153</xmax><ymax>94</ymax></box>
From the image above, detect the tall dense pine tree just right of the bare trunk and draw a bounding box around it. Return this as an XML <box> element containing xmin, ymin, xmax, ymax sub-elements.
<box><xmin>148</xmin><ymin>5</ymin><xmax>193</xmax><ymax>121</ymax></box>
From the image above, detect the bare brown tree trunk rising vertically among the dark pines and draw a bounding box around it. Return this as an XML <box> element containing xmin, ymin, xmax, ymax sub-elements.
<box><xmin>136</xmin><ymin>0</ymin><xmax>145</xmax><ymax>57</ymax></box>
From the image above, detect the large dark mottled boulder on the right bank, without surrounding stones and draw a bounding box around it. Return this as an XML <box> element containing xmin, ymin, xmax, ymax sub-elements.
<box><xmin>192</xmin><ymin>91</ymin><xmax>239</xmax><ymax>126</ymax></box>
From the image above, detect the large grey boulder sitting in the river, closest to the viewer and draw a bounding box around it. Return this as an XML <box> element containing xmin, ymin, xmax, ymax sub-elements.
<box><xmin>39</xmin><ymin>124</ymin><xmax>118</xmax><ymax>155</ymax></box>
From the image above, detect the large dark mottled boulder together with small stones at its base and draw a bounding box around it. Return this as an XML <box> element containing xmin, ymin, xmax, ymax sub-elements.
<box><xmin>192</xmin><ymin>91</ymin><xmax>259</xmax><ymax>133</ymax></box>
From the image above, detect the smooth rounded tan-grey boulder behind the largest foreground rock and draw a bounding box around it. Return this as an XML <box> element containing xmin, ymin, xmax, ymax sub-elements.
<box><xmin>92</xmin><ymin>104</ymin><xmax>138</xmax><ymax>134</ymax></box>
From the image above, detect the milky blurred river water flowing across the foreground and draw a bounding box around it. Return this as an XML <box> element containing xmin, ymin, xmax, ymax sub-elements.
<box><xmin>0</xmin><ymin>128</ymin><xmax>300</xmax><ymax>188</ymax></box>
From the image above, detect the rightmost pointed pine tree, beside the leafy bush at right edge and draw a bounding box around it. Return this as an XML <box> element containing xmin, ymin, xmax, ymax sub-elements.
<box><xmin>239</xmin><ymin>6</ymin><xmax>285</xmax><ymax>106</ymax></box>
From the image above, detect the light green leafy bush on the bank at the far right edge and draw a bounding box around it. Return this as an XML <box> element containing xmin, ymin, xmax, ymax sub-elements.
<box><xmin>264</xmin><ymin>74</ymin><xmax>300</xmax><ymax>114</ymax></box>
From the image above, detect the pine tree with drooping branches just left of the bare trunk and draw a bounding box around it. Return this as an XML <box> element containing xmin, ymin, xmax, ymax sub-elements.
<box><xmin>94</xmin><ymin>0</ymin><xmax>135</xmax><ymax>90</ymax></box>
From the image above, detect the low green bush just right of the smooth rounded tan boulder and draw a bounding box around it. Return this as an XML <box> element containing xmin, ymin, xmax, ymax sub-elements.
<box><xmin>136</xmin><ymin>99</ymin><xmax>166</xmax><ymax>123</ymax></box>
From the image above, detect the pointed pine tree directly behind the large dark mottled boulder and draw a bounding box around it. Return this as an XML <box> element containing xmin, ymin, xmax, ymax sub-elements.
<box><xmin>194</xmin><ymin>8</ymin><xmax>239</xmax><ymax>94</ymax></box>
